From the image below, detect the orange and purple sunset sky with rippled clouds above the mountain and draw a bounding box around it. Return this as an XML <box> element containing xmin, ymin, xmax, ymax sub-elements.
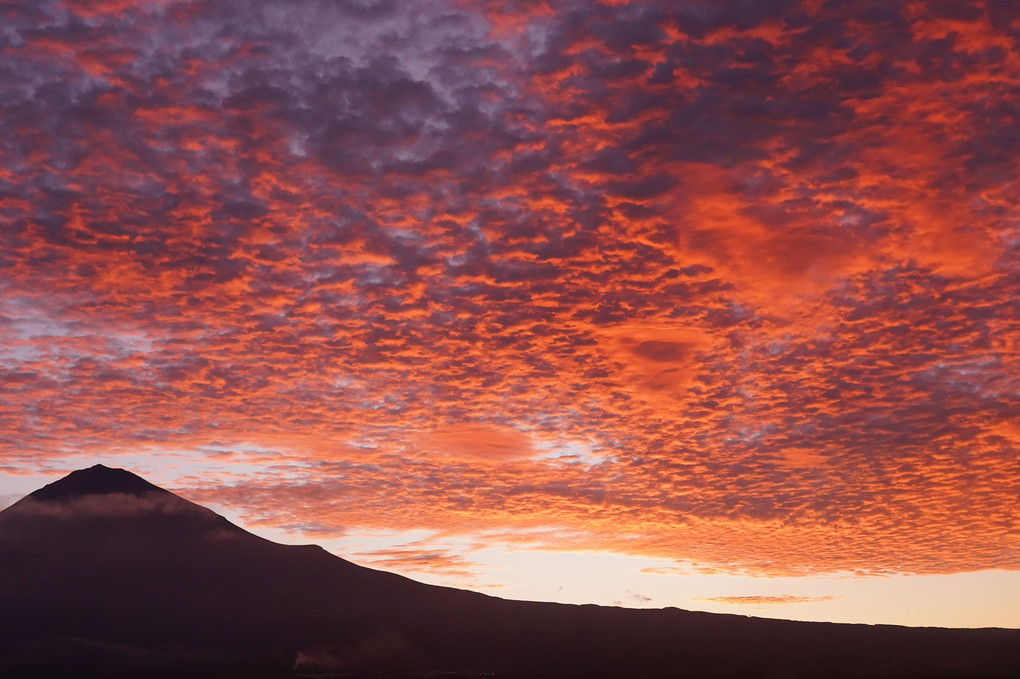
<box><xmin>0</xmin><ymin>0</ymin><xmax>1020</xmax><ymax>627</ymax></box>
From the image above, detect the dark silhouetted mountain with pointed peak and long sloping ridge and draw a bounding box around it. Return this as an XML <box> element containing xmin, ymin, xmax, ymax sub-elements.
<box><xmin>0</xmin><ymin>465</ymin><xmax>1020</xmax><ymax>679</ymax></box>
